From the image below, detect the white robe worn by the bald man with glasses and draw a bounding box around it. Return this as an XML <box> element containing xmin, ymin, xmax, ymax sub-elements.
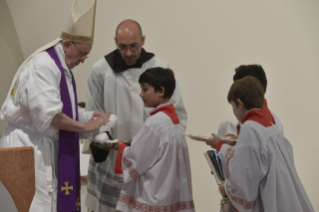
<box><xmin>86</xmin><ymin>57</ymin><xmax>187</xmax><ymax>212</ymax></box>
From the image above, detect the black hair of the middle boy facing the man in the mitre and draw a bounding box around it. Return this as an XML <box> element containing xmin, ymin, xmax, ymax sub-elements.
<box><xmin>138</xmin><ymin>67</ymin><xmax>176</xmax><ymax>99</ymax></box>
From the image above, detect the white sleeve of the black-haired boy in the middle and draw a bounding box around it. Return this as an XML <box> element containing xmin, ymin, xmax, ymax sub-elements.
<box><xmin>122</xmin><ymin>125</ymin><xmax>159</xmax><ymax>183</ymax></box>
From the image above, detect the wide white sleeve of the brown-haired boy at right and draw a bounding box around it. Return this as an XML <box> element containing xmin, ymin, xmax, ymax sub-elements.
<box><xmin>220</xmin><ymin>126</ymin><xmax>267</xmax><ymax>211</ymax></box>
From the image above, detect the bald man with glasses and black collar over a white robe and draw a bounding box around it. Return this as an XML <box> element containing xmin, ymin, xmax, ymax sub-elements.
<box><xmin>86</xmin><ymin>20</ymin><xmax>187</xmax><ymax>212</ymax></box>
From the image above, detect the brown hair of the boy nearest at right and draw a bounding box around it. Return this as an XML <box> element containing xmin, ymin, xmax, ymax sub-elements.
<box><xmin>227</xmin><ymin>76</ymin><xmax>264</xmax><ymax>110</ymax></box>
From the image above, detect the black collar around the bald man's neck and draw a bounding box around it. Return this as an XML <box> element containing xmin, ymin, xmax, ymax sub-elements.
<box><xmin>105</xmin><ymin>48</ymin><xmax>155</xmax><ymax>73</ymax></box>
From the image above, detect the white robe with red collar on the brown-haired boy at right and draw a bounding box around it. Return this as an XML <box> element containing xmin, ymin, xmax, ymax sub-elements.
<box><xmin>220</xmin><ymin>109</ymin><xmax>314</xmax><ymax>212</ymax></box>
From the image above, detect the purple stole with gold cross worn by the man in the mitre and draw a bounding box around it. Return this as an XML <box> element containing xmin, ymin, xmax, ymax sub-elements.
<box><xmin>46</xmin><ymin>47</ymin><xmax>81</xmax><ymax>212</ymax></box>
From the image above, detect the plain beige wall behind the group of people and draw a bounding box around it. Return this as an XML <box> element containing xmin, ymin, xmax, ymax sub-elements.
<box><xmin>0</xmin><ymin>0</ymin><xmax>319</xmax><ymax>212</ymax></box>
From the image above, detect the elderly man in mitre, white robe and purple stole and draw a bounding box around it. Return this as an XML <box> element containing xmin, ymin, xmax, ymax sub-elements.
<box><xmin>0</xmin><ymin>0</ymin><xmax>109</xmax><ymax>212</ymax></box>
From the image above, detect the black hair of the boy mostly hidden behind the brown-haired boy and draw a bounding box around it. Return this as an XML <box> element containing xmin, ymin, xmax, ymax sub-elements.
<box><xmin>233</xmin><ymin>64</ymin><xmax>267</xmax><ymax>93</ymax></box>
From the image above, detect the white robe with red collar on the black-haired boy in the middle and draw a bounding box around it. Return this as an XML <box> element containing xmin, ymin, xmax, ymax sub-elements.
<box><xmin>115</xmin><ymin>104</ymin><xmax>195</xmax><ymax>212</ymax></box>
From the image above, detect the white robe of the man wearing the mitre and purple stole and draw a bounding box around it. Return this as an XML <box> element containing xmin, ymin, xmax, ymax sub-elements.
<box><xmin>0</xmin><ymin>43</ymin><xmax>93</xmax><ymax>212</ymax></box>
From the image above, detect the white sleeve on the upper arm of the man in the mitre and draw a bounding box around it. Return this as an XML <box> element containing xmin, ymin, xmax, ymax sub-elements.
<box><xmin>19</xmin><ymin>58</ymin><xmax>63</xmax><ymax>132</ymax></box>
